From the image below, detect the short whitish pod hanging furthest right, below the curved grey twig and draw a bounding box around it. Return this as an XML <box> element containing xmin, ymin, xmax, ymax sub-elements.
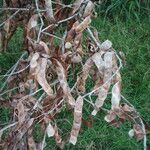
<box><xmin>111</xmin><ymin>82</ymin><xmax>121</xmax><ymax>109</ymax></box>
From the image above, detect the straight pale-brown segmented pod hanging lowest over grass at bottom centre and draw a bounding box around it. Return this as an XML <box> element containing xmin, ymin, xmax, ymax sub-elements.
<box><xmin>69</xmin><ymin>96</ymin><xmax>83</xmax><ymax>145</ymax></box>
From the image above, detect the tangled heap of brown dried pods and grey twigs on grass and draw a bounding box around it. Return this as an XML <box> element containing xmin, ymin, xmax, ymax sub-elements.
<box><xmin>0</xmin><ymin>0</ymin><xmax>146</xmax><ymax>150</ymax></box>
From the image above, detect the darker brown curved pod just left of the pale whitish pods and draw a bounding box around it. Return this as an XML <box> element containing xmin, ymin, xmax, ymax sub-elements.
<box><xmin>77</xmin><ymin>58</ymin><xmax>93</xmax><ymax>92</ymax></box>
